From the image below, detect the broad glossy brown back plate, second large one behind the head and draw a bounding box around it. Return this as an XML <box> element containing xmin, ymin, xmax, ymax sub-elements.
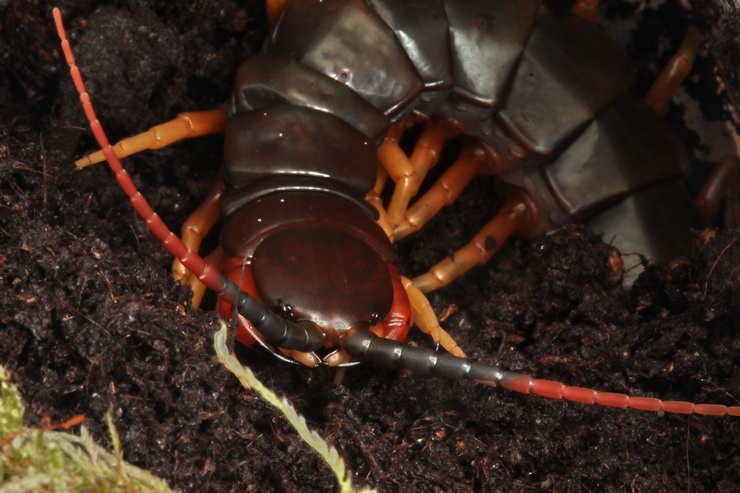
<box><xmin>223</xmin><ymin>104</ymin><xmax>377</xmax><ymax>216</ymax></box>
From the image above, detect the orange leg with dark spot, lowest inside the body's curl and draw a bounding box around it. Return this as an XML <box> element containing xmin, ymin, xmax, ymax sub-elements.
<box><xmin>414</xmin><ymin>195</ymin><xmax>532</xmax><ymax>293</ymax></box>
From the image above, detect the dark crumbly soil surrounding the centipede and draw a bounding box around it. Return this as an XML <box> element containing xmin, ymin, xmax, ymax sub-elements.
<box><xmin>0</xmin><ymin>0</ymin><xmax>740</xmax><ymax>492</ymax></box>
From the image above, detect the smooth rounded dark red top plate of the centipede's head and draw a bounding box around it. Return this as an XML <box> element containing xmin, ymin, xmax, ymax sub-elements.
<box><xmin>252</xmin><ymin>226</ymin><xmax>393</xmax><ymax>340</ymax></box>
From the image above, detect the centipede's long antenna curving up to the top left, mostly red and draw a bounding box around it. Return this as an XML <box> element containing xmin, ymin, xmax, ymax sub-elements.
<box><xmin>53</xmin><ymin>8</ymin><xmax>324</xmax><ymax>351</ymax></box>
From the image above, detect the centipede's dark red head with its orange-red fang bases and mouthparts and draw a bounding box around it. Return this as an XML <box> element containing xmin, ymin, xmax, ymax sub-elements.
<box><xmin>220</xmin><ymin>221</ymin><xmax>410</xmax><ymax>366</ymax></box>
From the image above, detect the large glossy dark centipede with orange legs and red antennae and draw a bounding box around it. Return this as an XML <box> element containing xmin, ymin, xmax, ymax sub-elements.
<box><xmin>7</xmin><ymin>1</ymin><xmax>738</xmax><ymax>490</ymax></box>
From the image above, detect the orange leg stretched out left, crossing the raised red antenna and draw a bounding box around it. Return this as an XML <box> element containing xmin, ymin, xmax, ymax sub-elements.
<box><xmin>75</xmin><ymin>104</ymin><xmax>226</xmax><ymax>168</ymax></box>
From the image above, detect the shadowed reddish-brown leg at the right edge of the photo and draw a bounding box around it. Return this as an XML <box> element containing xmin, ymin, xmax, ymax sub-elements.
<box><xmin>696</xmin><ymin>156</ymin><xmax>740</xmax><ymax>220</ymax></box>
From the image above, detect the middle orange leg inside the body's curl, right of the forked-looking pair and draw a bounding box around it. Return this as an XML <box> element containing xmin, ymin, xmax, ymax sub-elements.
<box><xmin>394</xmin><ymin>145</ymin><xmax>488</xmax><ymax>240</ymax></box>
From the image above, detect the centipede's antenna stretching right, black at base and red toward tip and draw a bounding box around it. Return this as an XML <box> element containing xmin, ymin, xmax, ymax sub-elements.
<box><xmin>341</xmin><ymin>327</ymin><xmax>740</xmax><ymax>416</ymax></box>
